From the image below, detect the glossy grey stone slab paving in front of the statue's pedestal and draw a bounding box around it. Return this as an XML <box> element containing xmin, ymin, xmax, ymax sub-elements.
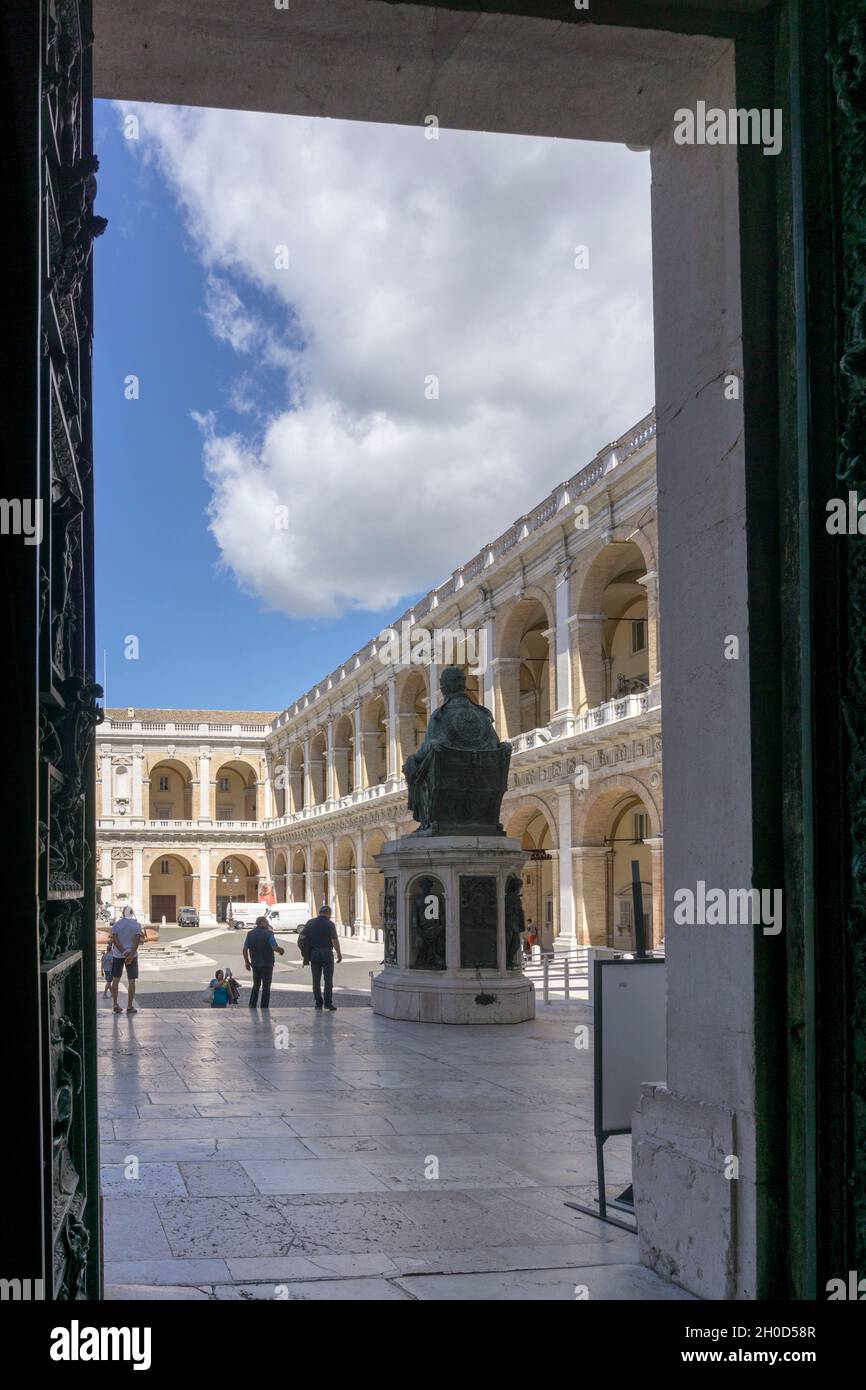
<box><xmin>99</xmin><ymin>1002</ymin><xmax>691</xmax><ymax>1301</ymax></box>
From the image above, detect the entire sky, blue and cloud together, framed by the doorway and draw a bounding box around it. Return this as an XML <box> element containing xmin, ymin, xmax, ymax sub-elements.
<box><xmin>95</xmin><ymin>101</ymin><xmax>652</xmax><ymax>710</ymax></box>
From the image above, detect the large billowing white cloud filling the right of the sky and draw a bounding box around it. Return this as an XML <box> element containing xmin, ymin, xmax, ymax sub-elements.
<box><xmin>124</xmin><ymin>106</ymin><xmax>652</xmax><ymax>617</ymax></box>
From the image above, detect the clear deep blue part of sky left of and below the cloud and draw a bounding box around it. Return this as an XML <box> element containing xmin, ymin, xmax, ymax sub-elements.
<box><xmin>93</xmin><ymin>101</ymin><xmax>411</xmax><ymax>710</ymax></box>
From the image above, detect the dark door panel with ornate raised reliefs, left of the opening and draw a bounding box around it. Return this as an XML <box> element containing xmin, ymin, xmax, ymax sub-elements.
<box><xmin>36</xmin><ymin>0</ymin><xmax>106</xmax><ymax>1298</ymax></box>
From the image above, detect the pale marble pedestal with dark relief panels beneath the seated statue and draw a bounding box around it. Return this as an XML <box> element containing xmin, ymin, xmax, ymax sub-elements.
<box><xmin>373</xmin><ymin>835</ymin><xmax>535</xmax><ymax>1023</ymax></box>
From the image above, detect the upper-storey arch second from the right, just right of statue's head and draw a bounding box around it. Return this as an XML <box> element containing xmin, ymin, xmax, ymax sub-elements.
<box><xmin>495</xmin><ymin>587</ymin><xmax>556</xmax><ymax>738</ymax></box>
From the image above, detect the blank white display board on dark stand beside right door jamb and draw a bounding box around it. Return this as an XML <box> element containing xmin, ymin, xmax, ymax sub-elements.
<box><xmin>595</xmin><ymin>960</ymin><xmax>667</xmax><ymax>1134</ymax></box>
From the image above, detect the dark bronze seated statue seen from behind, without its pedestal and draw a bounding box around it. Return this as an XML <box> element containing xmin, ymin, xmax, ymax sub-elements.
<box><xmin>403</xmin><ymin>666</ymin><xmax>512</xmax><ymax>835</ymax></box>
